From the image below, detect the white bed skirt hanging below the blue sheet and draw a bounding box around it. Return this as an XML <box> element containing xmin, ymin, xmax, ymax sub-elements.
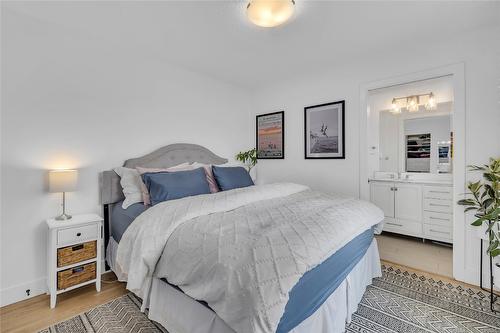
<box><xmin>146</xmin><ymin>238</ymin><xmax>382</xmax><ymax>333</ymax></box>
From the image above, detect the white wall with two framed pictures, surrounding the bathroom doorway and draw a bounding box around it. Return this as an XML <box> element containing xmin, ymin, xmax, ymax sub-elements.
<box><xmin>255</xmin><ymin>25</ymin><xmax>500</xmax><ymax>282</ymax></box>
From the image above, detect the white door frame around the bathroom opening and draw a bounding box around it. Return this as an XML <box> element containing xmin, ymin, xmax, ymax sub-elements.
<box><xmin>359</xmin><ymin>62</ymin><xmax>466</xmax><ymax>284</ymax></box>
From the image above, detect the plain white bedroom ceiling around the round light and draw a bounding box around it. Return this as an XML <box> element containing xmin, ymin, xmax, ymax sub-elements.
<box><xmin>2</xmin><ymin>0</ymin><xmax>500</xmax><ymax>87</ymax></box>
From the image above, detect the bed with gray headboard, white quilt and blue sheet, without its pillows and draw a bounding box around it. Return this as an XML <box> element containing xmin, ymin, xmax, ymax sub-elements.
<box><xmin>101</xmin><ymin>144</ymin><xmax>383</xmax><ymax>333</ymax></box>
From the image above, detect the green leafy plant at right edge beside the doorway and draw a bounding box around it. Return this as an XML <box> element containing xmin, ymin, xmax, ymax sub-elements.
<box><xmin>458</xmin><ymin>158</ymin><xmax>500</xmax><ymax>257</ymax></box>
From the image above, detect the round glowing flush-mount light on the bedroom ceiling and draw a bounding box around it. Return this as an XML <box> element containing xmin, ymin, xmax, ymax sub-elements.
<box><xmin>247</xmin><ymin>0</ymin><xmax>295</xmax><ymax>28</ymax></box>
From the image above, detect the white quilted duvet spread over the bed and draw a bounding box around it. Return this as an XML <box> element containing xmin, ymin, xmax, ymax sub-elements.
<box><xmin>117</xmin><ymin>183</ymin><xmax>384</xmax><ymax>333</ymax></box>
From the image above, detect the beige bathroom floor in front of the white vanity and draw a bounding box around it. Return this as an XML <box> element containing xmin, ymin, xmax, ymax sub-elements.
<box><xmin>376</xmin><ymin>233</ymin><xmax>453</xmax><ymax>278</ymax></box>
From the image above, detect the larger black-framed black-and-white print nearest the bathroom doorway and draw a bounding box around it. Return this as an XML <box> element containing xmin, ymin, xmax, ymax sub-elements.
<box><xmin>304</xmin><ymin>101</ymin><xmax>345</xmax><ymax>159</ymax></box>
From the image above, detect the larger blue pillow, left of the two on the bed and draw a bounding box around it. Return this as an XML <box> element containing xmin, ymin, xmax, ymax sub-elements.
<box><xmin>142</xmin><ymin>168</ymin><xmax>210</xmax><ymax>205</ymax></box>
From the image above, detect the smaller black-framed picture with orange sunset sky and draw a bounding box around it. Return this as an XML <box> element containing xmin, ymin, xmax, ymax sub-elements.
<box><xmin>255</xmin><ymin>111</ymin><xmax>285</xmax><ymax>159</ymax></box>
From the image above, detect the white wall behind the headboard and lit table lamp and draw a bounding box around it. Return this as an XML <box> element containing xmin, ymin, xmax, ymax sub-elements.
<box><xmin>0</xmin><ymin>9</ymin><xmax>253</xmax><ymax>305</ymax></box>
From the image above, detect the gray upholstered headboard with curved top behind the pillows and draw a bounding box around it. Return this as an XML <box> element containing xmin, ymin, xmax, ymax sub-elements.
<box><xmin>101</xmin><ymin>143</ymin><xmax>227</xmax><ymax>205</ymax></box>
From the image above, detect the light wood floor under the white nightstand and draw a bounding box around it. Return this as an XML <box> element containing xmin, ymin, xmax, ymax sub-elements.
<box><xmin>0</xmin><ymin>273</ymin><xmax>127</xmax><ymax>333</ymax></box>
